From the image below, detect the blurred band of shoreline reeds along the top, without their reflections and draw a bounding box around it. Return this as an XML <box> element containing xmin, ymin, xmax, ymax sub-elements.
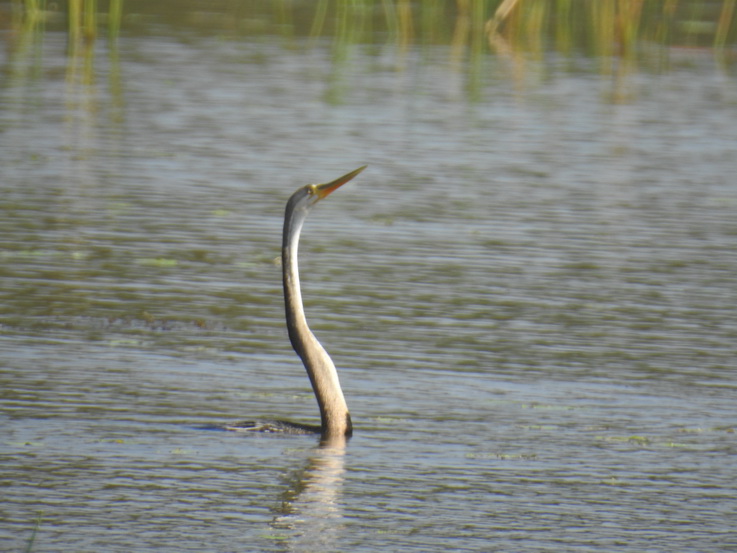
<box><xmin>6</xmin><ymin>0</ymin><xmax>737</xmax><ymax>53</ymax></box>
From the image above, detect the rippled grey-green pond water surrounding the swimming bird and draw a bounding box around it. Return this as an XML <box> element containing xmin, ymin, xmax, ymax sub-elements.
<box><xmin>0</xmin><ymin>9</ymin><xmax>737</xmax><ymax>552</ymax></box>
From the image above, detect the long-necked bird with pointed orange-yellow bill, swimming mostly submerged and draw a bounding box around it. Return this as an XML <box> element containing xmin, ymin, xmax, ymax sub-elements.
<box><xmin>225</xmin><ymin>165</ymin><xmax>367</xmax><ymax>439</ymax></box>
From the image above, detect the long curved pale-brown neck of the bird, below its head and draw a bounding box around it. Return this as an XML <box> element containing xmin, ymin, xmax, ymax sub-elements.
<box><xmin>282</xmin><ymin>203</ymin><xmax>353</xmax><ymax>436</ymax></box>
